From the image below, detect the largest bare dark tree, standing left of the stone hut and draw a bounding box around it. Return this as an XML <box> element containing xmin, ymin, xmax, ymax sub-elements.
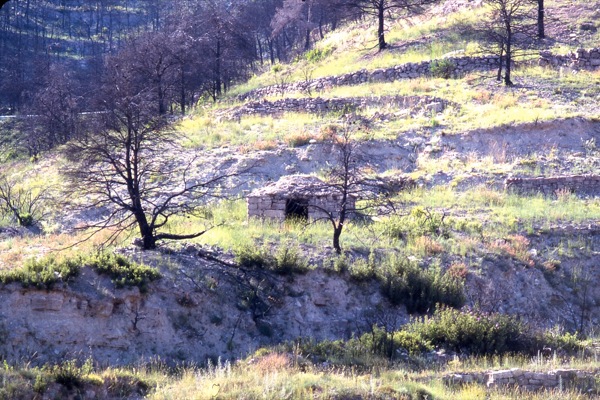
<box><xmin>65</xmin><ymin>54</ymin><xmax>244</xmax><ymax>249</ymax></box>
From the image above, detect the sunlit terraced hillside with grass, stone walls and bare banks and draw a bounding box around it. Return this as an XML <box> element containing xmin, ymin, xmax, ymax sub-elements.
<box><xmin>0</xmin><ymin>0</ymin><xmax>600</xmax><ymax>399</ymax></box>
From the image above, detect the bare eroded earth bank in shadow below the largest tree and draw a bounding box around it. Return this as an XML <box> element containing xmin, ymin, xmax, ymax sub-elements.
<box><xmin>0</xmin><ymin>258</ymin><xmax>392</xmax><ymax>365</ymax></box>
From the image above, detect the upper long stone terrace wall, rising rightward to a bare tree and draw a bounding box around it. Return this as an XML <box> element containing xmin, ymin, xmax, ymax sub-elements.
<box><xmin>237</xmin><ymin>56</ymin><xmax>499</xmax><ymax>101</ymax></box>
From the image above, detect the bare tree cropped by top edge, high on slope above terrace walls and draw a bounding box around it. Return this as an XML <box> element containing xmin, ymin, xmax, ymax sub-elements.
<box><xmin>342</xmin><ymin>0</ymin><xmax>437</xmax><ymax>50</ymax></box>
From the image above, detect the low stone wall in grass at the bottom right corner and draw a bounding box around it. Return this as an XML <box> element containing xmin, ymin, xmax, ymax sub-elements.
<box><xmin>444</xmin><ymin>368</ymin><xmax>597</xmax><ymax>391</ymax></box>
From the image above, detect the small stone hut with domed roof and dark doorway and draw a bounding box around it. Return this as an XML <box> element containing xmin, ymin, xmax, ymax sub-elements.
<box><xmin>246</xmin><ymin>175</ymin><xmax>355</xmax><ymax>221</ymax></box>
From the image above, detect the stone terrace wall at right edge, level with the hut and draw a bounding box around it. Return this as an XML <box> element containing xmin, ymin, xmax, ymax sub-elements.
<box><xmin>504</xmin><ymin>175</ymin><xmax>600</xmax><ymax>196</ymax></box>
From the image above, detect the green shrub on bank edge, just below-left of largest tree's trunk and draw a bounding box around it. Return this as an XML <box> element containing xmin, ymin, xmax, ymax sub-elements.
<box><xmin>85</xmin><ymin>252</ymin><xmax>160</xmax><ymax>293</ymax></box>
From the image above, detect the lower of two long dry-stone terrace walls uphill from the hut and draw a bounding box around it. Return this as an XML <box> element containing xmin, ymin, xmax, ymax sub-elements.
<box><xmin>215</xmin><ymin>96</ymin><xmax>450</xmax><ymax>120</ymax></box>
